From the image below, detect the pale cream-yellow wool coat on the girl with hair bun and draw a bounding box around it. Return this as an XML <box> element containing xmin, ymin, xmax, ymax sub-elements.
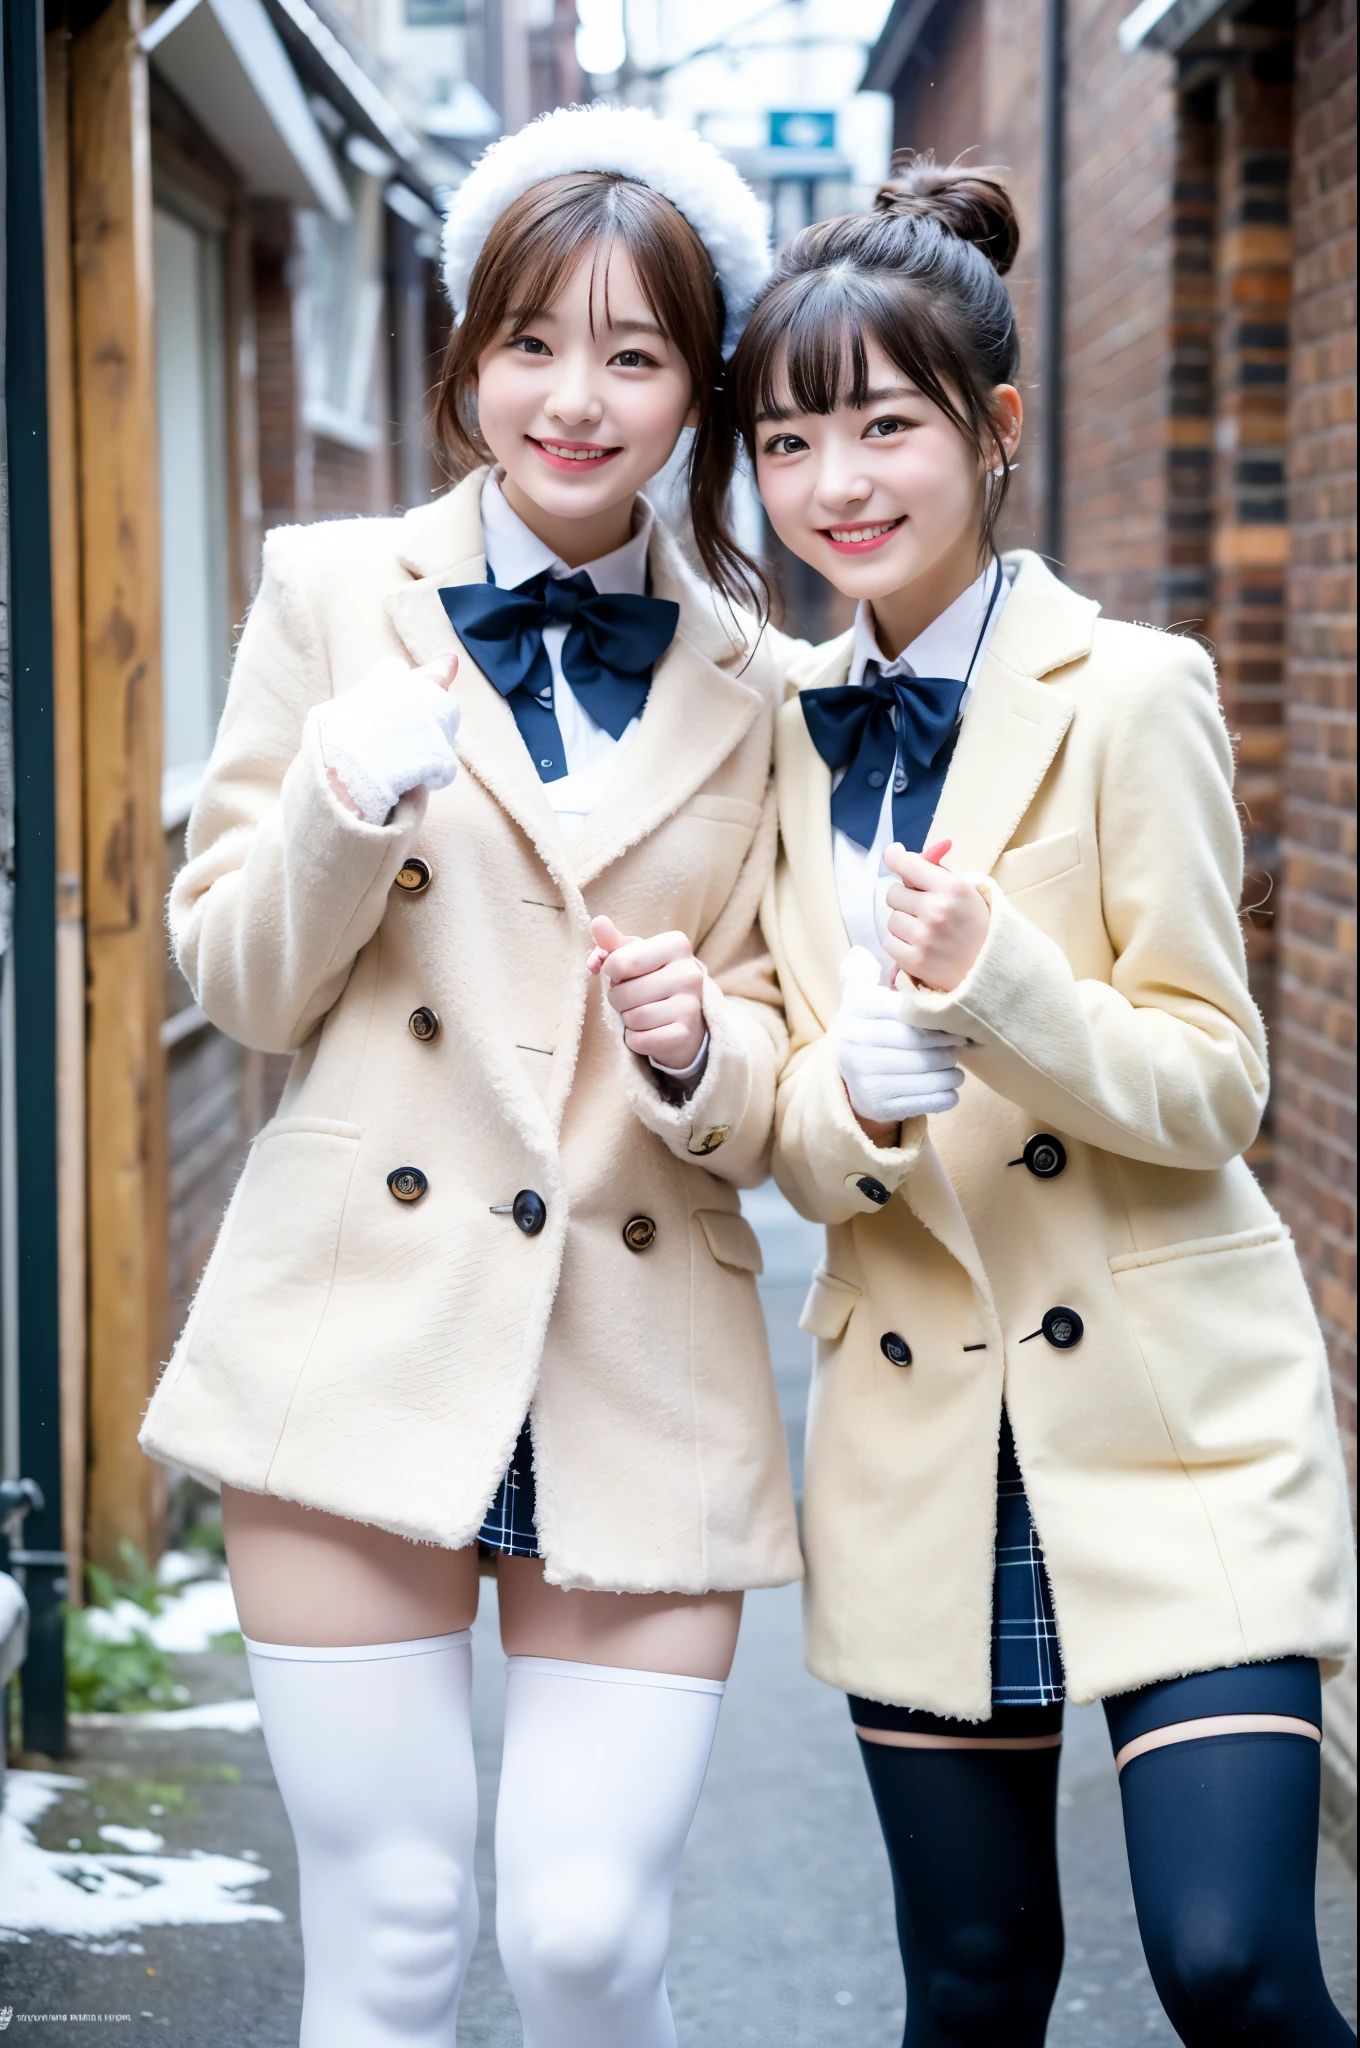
<box><xmin>764</xmin><ymin>553</ymin><xmax>1352</xmax><ymax>1720</ymax></box>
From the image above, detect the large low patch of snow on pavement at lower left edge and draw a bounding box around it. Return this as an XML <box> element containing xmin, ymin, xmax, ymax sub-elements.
<box><xmin>0</xmin><ymin>1777</ymin><xmax>283</xmax><ymax>1942</ymax></box>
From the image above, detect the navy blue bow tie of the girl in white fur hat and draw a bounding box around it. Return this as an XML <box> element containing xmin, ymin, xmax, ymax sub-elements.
<box><xmin>438</xmin><ymin>569</ymin><xmax>680</xmax><ymax>782</ymax></box>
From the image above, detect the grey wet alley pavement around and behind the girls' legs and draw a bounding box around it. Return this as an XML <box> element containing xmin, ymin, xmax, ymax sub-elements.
<box><xmin>0</xmin><ymin>1192</ymin><xmax>1356</xmax><ymax>2048</ymax></box>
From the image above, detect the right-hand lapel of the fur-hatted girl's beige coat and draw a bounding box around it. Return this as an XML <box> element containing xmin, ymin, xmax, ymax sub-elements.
<box><xmin>571</xmin><ymin>520</ymin><xmax>762</xmax><ymax>889</ymax></box>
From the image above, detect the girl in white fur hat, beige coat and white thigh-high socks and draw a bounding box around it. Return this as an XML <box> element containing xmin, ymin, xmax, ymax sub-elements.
<box><xmin>141</xmin><ymin>109</ymin><xmax>801</xmax><ymax>2048</ymax></box>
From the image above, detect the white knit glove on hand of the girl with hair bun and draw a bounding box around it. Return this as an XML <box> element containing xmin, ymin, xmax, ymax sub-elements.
<box><xmin>832</xmin><ymin>946</ymin><xmax>967</xmax><ymax>1124</ymax></box>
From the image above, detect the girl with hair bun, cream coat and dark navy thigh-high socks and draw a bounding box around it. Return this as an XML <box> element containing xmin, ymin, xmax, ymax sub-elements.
<box><xmin>731</xmin><ymin>160</ymin><xmax>1354</xmax><ymax>2048</ymax></box>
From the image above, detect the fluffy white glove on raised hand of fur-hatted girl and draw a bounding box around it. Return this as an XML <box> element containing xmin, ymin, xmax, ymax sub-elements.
<box><xmin>311</xmin><ymin>655</ymin><xmax>461</xmax><ymax>825</ymax></box>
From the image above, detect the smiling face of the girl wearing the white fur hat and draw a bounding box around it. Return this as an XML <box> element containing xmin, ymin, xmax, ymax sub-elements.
<box><xmin>477</xmin><ymin>242</ymin><xmax>696</xmax><ymax>563</ymax></box>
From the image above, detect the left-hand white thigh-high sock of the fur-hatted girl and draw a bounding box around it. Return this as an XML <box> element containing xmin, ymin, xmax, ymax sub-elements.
<box><xmin>246</xmin><ymin>1630</ymin><xmax>477</xmax><ymax>2048</ymax></box>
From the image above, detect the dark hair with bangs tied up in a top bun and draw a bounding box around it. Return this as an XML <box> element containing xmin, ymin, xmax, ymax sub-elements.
<box><xmin>729</xmin><ymin>154</ymin><xmax>1020</xmax><ymax>545</ymax></box>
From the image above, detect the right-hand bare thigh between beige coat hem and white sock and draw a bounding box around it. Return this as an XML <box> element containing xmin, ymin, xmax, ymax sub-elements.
<box><xmin>496</xmin><ymin>1556</ymin><xmax>741</xmax><ymax>1679</ymax></box>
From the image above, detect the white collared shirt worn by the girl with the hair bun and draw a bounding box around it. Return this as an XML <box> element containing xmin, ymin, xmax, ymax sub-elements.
<box><xmin>832</xmin><ymin>561</ymin><xmax>1010</xmax><ymax>967</ymax></box>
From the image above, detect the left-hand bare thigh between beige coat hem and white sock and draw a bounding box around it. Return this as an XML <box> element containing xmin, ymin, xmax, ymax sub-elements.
<box><xmin>221</xmin><ymin>1487</ymin><xmax>477</xmax><ymax>1649</ymax></box>
